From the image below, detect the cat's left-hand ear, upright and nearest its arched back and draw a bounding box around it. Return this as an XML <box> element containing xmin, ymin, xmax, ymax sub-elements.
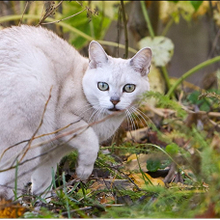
<box><xmin>89</xmin><ymin>40</ymin><xmax>108</xmax><ymax>69</ymax></box>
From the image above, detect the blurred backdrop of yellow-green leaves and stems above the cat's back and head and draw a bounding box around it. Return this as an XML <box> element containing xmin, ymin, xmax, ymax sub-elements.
<box><xmin>0</xmin><ymin>1</ymin><xmax>220</xmax><ymax>94</ymax></box>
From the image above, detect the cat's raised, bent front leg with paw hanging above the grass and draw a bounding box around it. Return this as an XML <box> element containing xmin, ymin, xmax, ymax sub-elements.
<box><xmin>59</xmin><ymin>112</ymin><xmax>99</xmax><ymax>180</ymax></box>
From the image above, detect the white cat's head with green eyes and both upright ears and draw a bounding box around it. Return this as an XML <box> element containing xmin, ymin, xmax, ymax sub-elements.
<box><xmin>83</xmin><ymin>41</ymin><xmax>152</xmax><ymax>114</ymax></box>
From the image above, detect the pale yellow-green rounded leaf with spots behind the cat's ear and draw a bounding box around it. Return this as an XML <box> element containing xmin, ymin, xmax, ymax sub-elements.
<box><xmin>138</xmin><ymin>36</ymin><xmax>174</xmax><ymax>66</ymax></box>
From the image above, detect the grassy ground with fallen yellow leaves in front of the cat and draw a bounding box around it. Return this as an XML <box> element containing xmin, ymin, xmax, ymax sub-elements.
<box><xmin>2</xmin><ymin>90</ymin><xmax>220</xmax><ymax>219</ymax></box>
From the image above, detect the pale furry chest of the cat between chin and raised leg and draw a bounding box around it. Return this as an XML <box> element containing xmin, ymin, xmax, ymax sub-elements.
<box><xmin>92</xmin><ymin>115</ymin><xmax>125</xmax><ymax>142</ymax></box>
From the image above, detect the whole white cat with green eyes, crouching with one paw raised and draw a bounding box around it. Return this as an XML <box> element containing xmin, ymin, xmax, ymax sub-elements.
<box><xmin>0</xmin><ymin>25</ymin><xmax>152</xmax><ymax>199</ymax></box>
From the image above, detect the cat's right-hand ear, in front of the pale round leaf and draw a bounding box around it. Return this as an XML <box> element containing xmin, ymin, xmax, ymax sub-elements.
<box><xmin>130</xmin><ymin>47</ymin><xmax>152</xmax><ymax>76</ymax></box>
